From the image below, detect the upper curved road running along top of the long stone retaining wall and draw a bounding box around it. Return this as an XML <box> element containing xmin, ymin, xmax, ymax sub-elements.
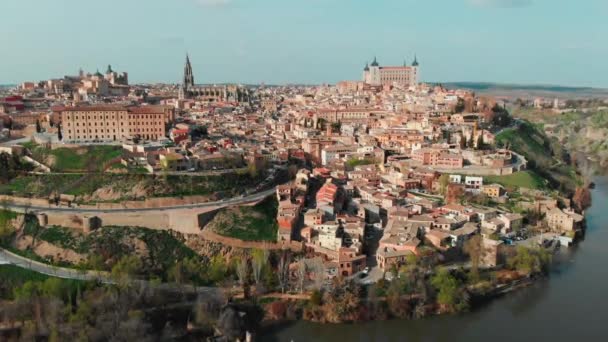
<box><xmin>6</xmin><ymin>188</ymin><xmax>276</xmax><ymax>214</ymax></box>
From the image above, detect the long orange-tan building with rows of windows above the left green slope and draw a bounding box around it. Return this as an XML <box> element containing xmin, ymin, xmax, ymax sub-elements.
<box><xmin>56</xmin><ymin>106</ymin><xmax>173</xmax><ymax>142</ymax></box>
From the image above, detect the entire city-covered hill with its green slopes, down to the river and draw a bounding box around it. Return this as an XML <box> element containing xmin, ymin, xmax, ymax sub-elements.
<box><xmin>0</xmin><ymin>56</ymin><xmax>589</xmax><ymax>338</ymax></box>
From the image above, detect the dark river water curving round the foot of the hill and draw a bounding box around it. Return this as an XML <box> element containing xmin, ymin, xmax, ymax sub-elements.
<box><xmin>259</xmin><ymin>177</ymin><xmax>608</xmax><ymax>342</ymax></box>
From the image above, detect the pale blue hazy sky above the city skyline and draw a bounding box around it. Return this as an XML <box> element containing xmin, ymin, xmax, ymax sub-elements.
<box><xmin>0</xmin><ymin>0</ymin><xmax>608</xmax><ymax>88</ymax></box>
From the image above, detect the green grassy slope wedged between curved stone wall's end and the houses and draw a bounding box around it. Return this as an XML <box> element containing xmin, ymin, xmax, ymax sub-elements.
<box><xmin>208</xmin><ymin>197</ymin><xmax>279</xmax><ymax>242</ymax></box>
